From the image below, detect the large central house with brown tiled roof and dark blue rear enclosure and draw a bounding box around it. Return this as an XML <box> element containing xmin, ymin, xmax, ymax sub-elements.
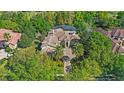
<box><xmin>41</xmin><ymin>25</ymin><xmax>80</xmax><ymax>55</ymax></box>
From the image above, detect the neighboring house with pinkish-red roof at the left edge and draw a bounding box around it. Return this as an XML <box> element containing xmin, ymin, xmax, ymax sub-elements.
<box><xmin>0</xmin><ymin>29</ymin><xmax>21</xmax><ymax>49</ymax></box>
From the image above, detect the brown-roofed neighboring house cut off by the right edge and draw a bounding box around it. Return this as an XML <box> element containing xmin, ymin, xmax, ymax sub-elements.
<box><xmin>97</xmin><ymin>28</ymin><xmax>124</xmax><ymax>54</ymax></box>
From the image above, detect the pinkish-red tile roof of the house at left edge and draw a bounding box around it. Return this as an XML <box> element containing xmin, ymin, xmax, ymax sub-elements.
<box><xmin>0</xmin><ymin>29</ymin><xmax>21</xmax><ymax>45</ymax></box>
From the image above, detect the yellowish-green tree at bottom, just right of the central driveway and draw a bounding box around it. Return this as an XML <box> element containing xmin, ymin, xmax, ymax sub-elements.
<box><xmin>66</xmin><ymin>58</ymin><xmax>102</xmax><ymax>80</ymax></box>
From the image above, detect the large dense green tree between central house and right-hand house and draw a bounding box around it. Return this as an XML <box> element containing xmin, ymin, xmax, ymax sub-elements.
<box><xmin>85</xmin><ymin>32</ymin><xmax>112</xmax><ymax>74</ymax></box>
